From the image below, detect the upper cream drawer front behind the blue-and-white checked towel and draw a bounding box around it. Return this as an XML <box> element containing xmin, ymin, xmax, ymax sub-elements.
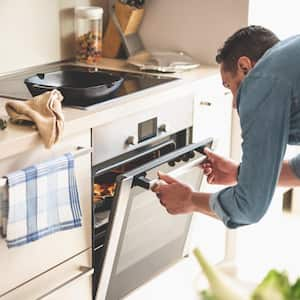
<box><xmin>0</xmin><ymin>131</ymin><xmax>91</xmax><ymax>299</ymax></box>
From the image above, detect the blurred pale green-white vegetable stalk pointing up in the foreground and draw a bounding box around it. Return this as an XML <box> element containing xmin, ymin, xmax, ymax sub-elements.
<box><xmin>194</xmin><ymin>249</ymin><xmax>250</xmax><ymax>300</ymax></box>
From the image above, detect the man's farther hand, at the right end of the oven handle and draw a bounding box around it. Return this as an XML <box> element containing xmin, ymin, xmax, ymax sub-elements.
<box><xmin>200</xmin><ymin>148</ymin><xmax>239</xmax><ymax>185</ymax></box>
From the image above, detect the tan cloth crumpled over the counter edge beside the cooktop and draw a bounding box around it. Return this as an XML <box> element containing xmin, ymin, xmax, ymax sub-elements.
<box><xmin>5</xmin><ymin>90</ymin><xmax>64</xmax><ymax>148</ymax></box>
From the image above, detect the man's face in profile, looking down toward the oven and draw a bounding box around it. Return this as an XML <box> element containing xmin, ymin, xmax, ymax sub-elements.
<box><xmin>220</xmin><ymin>63</ymin><xmax>246</xmax><ymax>108</ymax></box>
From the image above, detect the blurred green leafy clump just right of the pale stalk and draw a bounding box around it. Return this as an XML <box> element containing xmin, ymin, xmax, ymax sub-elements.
<box><xmin>252</xmin><ymin>270</ymin><xmax>291</xmax><ymax>300</ymax></box>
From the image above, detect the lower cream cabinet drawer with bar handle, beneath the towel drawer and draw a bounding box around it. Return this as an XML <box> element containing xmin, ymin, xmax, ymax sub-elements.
<box><xmin>1</xmin><ymin>249</ymin><xmax>93</xmax><ymax>300</ymax></box>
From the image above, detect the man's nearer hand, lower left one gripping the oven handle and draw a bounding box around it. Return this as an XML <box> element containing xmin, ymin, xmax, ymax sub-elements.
<box><xmin>152</xmin><ymin>172</ymin><xmax>195</xmax><ymax>215</ymax></box>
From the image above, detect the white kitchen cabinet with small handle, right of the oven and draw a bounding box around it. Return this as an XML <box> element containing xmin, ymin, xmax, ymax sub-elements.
<box><xmin>192</xmin><ymin>76</ymin><xmax>232</xmax><ymax>262</ymax></box>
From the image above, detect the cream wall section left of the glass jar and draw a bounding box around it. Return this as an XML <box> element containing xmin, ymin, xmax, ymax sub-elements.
<box><xmin>0</xmin><ymin>0</ymin><xmax>106</xmax><ymax>73</ymax></box>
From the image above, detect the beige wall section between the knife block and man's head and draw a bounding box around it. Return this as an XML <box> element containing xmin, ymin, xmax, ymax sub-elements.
<box><xmin>140</xmin><ymin>0</ymin><xmax>248</xmax><ymax>64</ymax></box>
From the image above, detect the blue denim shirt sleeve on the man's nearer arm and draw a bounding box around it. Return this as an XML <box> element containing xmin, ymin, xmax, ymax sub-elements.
<box><xmin>210</xmin><ymin>75</ymin><xmax>292</xmax><ymax>228</ymax></box>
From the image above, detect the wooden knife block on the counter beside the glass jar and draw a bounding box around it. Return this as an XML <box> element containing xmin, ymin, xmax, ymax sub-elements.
<box><xmin>103</xmin><ymin>1</ymin><xmax>144</xmax><ymax>58</ymax></box>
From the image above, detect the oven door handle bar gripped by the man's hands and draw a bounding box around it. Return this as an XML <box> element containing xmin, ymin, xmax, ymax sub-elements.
<box><xmin>133</xmin><ymin>155</ymin><xmax>206</xmax><ymax>190</ymax></box>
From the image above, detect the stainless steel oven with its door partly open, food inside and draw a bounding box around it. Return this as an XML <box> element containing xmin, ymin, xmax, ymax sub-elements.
<box><xmin>93</xmin><ymin>110</ymin><xmax>212</xmax><ymax>300</ymax></box>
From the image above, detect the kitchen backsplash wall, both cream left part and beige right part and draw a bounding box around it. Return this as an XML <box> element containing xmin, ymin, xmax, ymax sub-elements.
<box><xmin>0</xmin><ymin>0</ymin><xmax>249</xmax><ymax>73</ymax></box>
